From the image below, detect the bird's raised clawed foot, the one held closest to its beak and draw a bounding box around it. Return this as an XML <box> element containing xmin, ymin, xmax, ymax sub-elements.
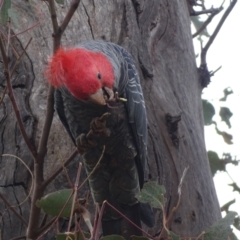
<box><xmin>90</xmin><ymin>112</ymin><xmax>111</xmax><ymax>137</ymax></box>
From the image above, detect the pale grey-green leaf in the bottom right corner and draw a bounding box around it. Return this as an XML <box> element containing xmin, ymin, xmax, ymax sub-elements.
<box><xmin>204</xmin><ymin>212</ymin><xmax>237</xmax><ymax>240</ymax></box>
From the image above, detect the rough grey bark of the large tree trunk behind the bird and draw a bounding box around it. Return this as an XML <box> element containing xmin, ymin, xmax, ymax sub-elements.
<box><xmin>0</xmin><ymin>0</ymin><xmax>220</xmax><ymax>239</ymax></box>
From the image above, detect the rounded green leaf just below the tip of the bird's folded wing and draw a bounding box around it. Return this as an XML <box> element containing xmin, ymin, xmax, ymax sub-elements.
<box><xmin>136</xmin><ymin>182</ymin><xmax>166</xmax><ymax>209</ymax></box>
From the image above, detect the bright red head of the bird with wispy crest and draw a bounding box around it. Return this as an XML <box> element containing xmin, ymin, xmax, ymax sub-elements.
<box><xmin>46</xmin><ymin>48</ymin><xmax>114</xmax><ymax>100</ymax></box>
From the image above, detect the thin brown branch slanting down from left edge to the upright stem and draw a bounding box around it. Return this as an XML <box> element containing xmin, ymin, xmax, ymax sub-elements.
<box><xmin>0</xmin><ymin>33</ymin><xmax>37</xmax><ymax>158</ymax></box>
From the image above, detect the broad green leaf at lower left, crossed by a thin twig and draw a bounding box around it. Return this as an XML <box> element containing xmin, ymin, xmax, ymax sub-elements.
<box><xmin>36</xmin><ymin>189</ymin><xmax>73</xmax><ymax>217</ymax></box>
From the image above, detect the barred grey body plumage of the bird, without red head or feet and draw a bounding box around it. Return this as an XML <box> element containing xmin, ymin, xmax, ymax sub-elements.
<box><xmin>55</xmin><ymin>41</ymin><xmax>154</xmax><ymax>239</ymax></box>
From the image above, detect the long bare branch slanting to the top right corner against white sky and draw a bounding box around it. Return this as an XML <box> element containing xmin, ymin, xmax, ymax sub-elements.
<box><xmin>201</xmin><ymin>0</ymin><xmax>237</xmax><ymax>66</ymax></box>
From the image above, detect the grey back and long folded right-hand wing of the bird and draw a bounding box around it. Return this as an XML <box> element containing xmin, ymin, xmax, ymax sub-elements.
<box><xmin>78</xmin><ymin>41</ymin><xmax>147</xmax><ymax>187</ymax></box>
